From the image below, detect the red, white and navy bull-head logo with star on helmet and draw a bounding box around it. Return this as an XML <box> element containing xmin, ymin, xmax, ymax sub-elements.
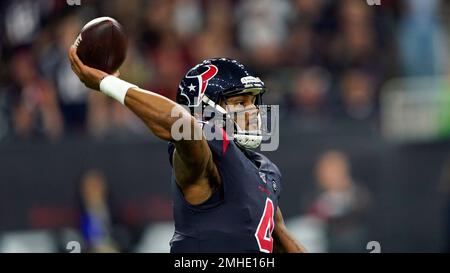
<box><xmin>179</xmin><ymin>64</ymin><xmax>219</xmax><ymax>107</ymax></box>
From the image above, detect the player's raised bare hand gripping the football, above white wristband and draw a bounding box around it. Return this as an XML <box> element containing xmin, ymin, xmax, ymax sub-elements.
<box><xmin>69</xmin><ymin>46</ymin><xmax>109</xmax><ymax>90</ymax></box>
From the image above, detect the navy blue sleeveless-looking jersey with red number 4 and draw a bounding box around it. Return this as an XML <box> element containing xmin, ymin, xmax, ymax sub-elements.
<box><xmin>169</xmin><ymin>124</ymin><xmax>281</xmax><ymax>253</ymax></box>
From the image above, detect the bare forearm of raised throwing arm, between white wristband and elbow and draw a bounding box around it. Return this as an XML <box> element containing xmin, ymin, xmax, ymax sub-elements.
<box><xmin>125</xmin><ymin>88</ymin><xmax>194</xmax><ymax>141</ymax></box>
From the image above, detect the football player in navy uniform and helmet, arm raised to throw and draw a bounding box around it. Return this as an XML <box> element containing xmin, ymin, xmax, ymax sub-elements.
<box><xmin>69</xmin><ymin>48</ymin><xmax>305</xmax><ymax>253</ymax></box>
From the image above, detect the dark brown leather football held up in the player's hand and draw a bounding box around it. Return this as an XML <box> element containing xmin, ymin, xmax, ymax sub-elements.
<box><xmin>74</xmin><ymin>17</ymin><xmax>128</xmax><ymax>74</ymax></box>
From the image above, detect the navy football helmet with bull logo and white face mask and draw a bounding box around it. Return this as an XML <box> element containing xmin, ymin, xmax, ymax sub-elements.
<box><xmin>176</xmin><ymin>58</ymin><xmax>266</xmax><ymax>148</ymax></box>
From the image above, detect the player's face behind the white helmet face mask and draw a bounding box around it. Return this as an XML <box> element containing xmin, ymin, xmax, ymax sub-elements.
<box><xmin>221</xmin><ymin>93</ymin><xmax>259</xmax><ymax>131</ymax></box>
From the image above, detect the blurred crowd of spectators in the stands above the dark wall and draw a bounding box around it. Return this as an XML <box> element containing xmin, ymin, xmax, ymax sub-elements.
<box><xmin>0</xmin><ymin>0</ymin><xmax>449</xmax><ymax>141</ymax></box>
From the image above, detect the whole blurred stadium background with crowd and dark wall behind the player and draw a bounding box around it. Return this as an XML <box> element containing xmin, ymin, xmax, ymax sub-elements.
<box><xmin>0</xmin><ymin>0</ymin><xmax>450</xmax><ymax>252</ymax></box>
